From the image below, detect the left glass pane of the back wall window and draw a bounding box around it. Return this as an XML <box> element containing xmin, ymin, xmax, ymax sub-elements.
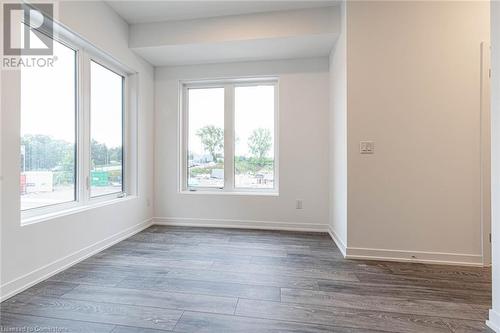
<box><xmin>188</xmin><ymin>88</ymin><xmax>224</xmax><ymax>188</ymax></box>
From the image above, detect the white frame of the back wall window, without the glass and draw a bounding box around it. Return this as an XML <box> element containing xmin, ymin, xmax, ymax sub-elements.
<box><xmin>178</xmin><ymin>76</ymin><xmax>279</xmax><ymax>195</ymax></box>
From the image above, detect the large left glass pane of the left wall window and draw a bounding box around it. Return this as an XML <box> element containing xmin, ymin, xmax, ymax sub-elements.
<box><xmin>20</xmin><ymin>41</ymin><xmax>76</xmax><ymax>210</ymax></box>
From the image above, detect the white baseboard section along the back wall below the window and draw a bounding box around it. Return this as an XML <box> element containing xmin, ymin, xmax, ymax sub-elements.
<box><xmin>153</xmin><ymin>217</ymin><xmax>328</xmax><ymax>232</ymax></box>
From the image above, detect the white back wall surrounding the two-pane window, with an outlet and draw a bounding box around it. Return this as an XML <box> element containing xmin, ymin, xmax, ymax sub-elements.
<box><xmin>155</xmin><ymin>58</ymin><xmax>329</xmax><ymax>231</ymax></box>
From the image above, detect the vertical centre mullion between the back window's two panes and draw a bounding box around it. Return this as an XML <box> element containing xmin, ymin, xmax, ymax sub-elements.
<box><xmin>224</xmin><ymin>85</ymin><xmax>234</xmax><ymax>191</ymax></box>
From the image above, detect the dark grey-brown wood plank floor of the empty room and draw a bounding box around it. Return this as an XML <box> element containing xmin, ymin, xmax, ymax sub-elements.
<box><xmin>0</xmin><ymin>226</ymin><xmax>491</xmax><ymax>333</ymax></box>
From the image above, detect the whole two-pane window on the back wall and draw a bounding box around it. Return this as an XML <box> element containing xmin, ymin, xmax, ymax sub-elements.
<box><xmin>181</xmin><ymin>79</ymin><xmax>278</xmax><ymax>192</ymax></box>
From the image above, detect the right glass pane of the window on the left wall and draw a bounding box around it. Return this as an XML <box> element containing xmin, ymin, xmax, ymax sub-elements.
<box><xmin>90</xmin><ymin>61</ymin><xmax>123</xmax><ymax>197</ymax></box>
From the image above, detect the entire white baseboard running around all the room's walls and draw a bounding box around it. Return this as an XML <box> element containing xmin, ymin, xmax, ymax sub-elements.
<box><xmin>0</xmin><ymin>217</ymin><xmax>484</xmax><ymax>300</ymax></box>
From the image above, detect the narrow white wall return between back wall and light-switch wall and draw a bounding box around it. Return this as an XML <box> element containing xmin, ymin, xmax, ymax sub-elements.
<box><xmin>329</xmin><ymin>2</ymin><xmax>347</xmax><ymax>254</ymax></box>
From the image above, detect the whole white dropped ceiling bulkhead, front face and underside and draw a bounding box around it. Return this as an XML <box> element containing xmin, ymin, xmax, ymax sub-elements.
<box><xmin>129</xmin><ymin>6</ymin><xmax>339</xmax><ymax>67</ymax></box>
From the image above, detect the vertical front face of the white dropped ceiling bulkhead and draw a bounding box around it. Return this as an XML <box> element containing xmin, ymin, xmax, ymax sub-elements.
<box><xmin>130</xmin><ymin>7</ymin><xmax>338</xmax><ymax>48</ymax></box>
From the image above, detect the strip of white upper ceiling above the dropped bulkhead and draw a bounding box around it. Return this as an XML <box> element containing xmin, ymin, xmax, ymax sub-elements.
<box><xmin>107</xmin><ymin>0</ymin><xmax>339</xmax><ymax>24</ymax></box>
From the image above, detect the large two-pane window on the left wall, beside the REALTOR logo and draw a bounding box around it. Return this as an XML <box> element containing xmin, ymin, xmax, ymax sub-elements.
<box><xmin>20</xmin><ymin>20</ymin><xmax>137</xmax><ymax>218</ymax></box>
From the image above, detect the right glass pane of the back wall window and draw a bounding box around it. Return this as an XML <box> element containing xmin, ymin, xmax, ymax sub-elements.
<box><xmin>234</xmin><ymin>85</ymin><xmax>274</xmax><ymax>189</ymax></box>
